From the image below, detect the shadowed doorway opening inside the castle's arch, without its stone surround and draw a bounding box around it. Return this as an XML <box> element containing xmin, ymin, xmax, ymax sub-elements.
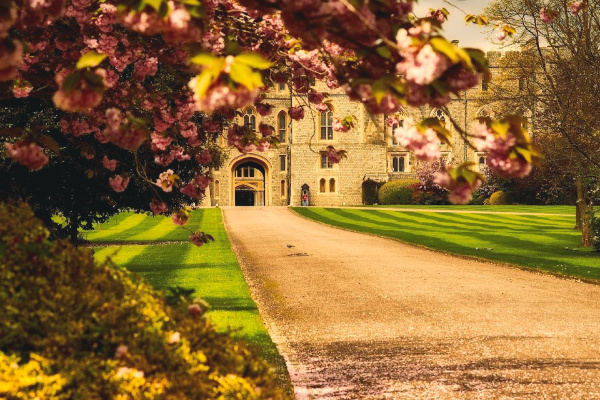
<box><xmin>233</xmin><ymin>160</ymin><xmax>266</xmax><ymax>207</ymax></box>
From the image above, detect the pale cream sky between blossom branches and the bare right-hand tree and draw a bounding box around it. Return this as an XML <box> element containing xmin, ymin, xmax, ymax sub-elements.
<box><xmin>413</xmin><ymin>0</ymin><xmax>500</xmax><ymax>50</ymax></box>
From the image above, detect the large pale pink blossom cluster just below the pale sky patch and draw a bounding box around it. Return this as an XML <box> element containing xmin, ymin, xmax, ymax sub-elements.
<box><xmin>396</xmin><ymin>44</ymin><xmax>451</xmax><ymax>85</ymax></box>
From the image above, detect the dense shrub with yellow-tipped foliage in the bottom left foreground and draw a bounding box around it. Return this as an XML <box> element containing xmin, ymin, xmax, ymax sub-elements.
<box><xmin>0</xmin><ymin>204</ymin><xmax>286</xmax><ymax>400</ymax></box>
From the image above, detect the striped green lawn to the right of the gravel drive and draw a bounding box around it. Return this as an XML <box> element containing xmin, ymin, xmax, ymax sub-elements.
<box><xmin>292</xmin><ymin>206</ymin><xmax>600</xmax><ymax>280</ymax></box>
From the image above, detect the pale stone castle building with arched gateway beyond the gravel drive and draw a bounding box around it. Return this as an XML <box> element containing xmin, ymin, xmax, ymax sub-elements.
<box><xmin>210</xmin><ymin>53</ymin><xmax>506</xmax><ymax>206</ymax></box>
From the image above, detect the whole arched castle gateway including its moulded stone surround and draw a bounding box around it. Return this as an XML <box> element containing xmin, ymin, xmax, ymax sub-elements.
<box><xmin>230</xmin><ymin>156</ymin><xmax>270</xmax><ymax>207</ymax></box>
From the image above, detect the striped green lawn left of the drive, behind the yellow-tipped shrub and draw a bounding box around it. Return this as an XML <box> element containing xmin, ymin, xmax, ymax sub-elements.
<box><xmin>85</xmin><ymin>208</ymin><xmax>291</xmax><ymax>393</ymax></box>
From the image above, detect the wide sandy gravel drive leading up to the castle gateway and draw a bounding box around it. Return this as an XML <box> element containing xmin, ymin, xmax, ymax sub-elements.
<box><xmin>224</xmin><ymin>207</ymin><xmax>600</xmax><ymax>400</ymax></box>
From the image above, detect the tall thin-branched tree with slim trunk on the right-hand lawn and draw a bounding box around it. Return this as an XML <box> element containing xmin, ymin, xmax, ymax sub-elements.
<box><xmin>486</xmin><ymin>0</ymin><xmax>600</xmax><ymax>246</ymax></box>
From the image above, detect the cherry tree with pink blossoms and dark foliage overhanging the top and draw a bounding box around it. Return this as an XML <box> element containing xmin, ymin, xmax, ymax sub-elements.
<box><xmin>0</xmin><ymin>0</ymin><xmax>537</xmax><ymax>231</ymax></box>
